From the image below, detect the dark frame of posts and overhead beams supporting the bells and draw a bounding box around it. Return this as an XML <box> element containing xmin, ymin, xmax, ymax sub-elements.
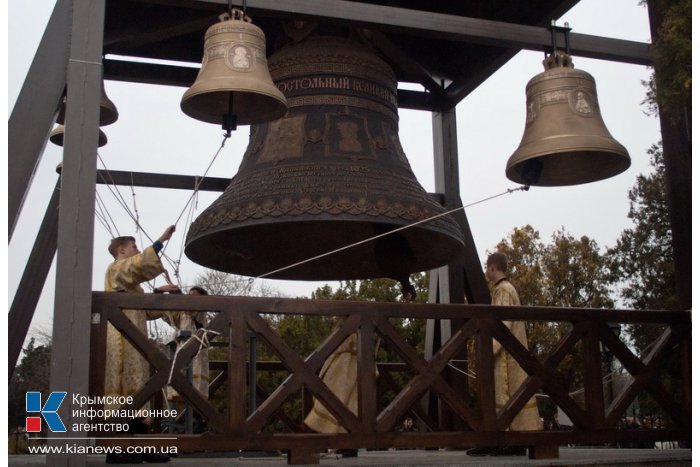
<box><xmin>8</xmin><ymin>0</ymin><xmax>691</xmax><ymax>465</ymax></box>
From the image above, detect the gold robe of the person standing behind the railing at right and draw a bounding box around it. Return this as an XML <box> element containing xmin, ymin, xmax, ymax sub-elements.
<box><xmin>491</xmin><ymin>280</ymin><xmax>540</xmax><ymax>431</ymax></box>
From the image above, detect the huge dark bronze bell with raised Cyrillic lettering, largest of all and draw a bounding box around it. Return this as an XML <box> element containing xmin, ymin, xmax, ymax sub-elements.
<box><xmin>185</xmin><ymin>37</ymin><xmax>463</xmax><ymax>280</ymax></box>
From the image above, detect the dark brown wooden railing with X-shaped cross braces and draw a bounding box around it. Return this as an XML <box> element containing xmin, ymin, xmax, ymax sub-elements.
<box><xmin>90</xmin><ymin>292</ymin><xmax>691</xmax><ymax>463</ymax></box>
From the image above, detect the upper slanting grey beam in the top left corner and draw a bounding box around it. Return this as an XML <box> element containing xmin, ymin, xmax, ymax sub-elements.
<box><xmin>7</xmin><ymin>0</ymin><xmax>73</xmax><ymax>240</ymax></box>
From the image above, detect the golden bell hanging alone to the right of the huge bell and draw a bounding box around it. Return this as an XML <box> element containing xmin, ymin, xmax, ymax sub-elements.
<box><xmin>506</xmin><ymin>51</ymin><xmax>630</xmax><ymax>186</ymax></box>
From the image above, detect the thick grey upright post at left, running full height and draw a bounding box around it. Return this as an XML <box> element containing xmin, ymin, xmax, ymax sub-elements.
<box><xmin>46</xmin><ymin>0</ymin><xmax>105</xmax><ymax>466</ymax></box>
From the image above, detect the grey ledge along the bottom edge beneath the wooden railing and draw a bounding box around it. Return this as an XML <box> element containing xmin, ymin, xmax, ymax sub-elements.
<box><xmin>9</xmin><ymin>447</ymin><xmax>692</xmax><ymax>467</ymax></box>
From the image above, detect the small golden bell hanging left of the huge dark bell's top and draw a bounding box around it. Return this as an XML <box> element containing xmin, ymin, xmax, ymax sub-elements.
<box><xmin>180</xmin><ymin>9</ymin><xmax>287</xmax><ymax>129</ymax></box>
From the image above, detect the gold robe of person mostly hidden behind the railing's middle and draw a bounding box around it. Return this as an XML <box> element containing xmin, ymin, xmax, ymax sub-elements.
<box><xmin>304</xmin><ymin>334</ymin><xmax>357</xmax><ymax>433</ymax></box>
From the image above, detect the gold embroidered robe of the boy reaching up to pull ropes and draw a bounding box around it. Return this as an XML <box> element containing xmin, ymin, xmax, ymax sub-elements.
<box><xmin>104</xmin><ymin>246</ymin><xmax>164</xmax><ymax>408</ymax></box>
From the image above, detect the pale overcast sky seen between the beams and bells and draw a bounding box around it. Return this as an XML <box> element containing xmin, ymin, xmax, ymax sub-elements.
<box><xmin>7</xmin><ymin>0</ymin><xmax>661</xmax><ymax>348</ymax></box>
